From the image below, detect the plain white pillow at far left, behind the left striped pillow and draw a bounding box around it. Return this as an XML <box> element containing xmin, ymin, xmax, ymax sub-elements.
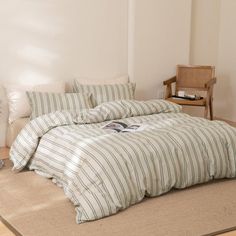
<box><xmin>5</xmin><ymin>82</ymin><xmax>65</xmax><ymax>124</ymax></box>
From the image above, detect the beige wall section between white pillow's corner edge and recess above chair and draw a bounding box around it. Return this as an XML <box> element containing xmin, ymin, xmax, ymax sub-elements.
<box><xmin>132</xmin><ymin>0</ymin><xmax>191</xmax><ymax>99</ymax></box>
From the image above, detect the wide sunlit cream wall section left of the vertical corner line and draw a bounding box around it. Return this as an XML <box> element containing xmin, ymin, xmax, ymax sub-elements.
<box><xmin>0</xmin><ymin>0</ymin><xmax>128</xmax><ymax>144</ymax></box>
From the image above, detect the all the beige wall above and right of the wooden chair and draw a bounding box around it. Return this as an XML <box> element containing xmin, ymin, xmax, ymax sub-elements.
<box><xmin>188</xmin><ymin>0</ymin><xmax>236</xmax><ymax>121</ymax></box>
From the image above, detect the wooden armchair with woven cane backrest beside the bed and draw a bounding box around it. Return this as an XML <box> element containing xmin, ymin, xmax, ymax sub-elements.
<box><xmin>163</xmin><ymin>65</ymin><xmax>216</xmax><ymax>120</ymax></box>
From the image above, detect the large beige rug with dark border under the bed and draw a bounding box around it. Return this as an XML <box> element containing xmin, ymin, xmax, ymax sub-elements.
<box><xmin>0</xmin><ymin>160</ymin><xmax>236</xmax><ymax>236</ymax></box>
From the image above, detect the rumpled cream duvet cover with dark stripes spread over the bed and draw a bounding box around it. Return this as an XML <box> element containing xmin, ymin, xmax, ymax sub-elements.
<box><xmin>10</xmin><ymin>100</ymin><xmax>236</xmax><ymax>223</ymax></box>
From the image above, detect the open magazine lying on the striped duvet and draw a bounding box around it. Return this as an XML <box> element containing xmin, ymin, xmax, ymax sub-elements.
<box><xmin>102</xmin><ymin>121</ymin><xmax>145</xmax><ymax>133</ymax></box>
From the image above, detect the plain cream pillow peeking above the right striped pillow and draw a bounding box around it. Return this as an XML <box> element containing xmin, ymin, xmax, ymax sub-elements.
<box><xmin>76</xmin><ymin>75</ymin><xmax>129</xmax><ymax>85</ymax></box>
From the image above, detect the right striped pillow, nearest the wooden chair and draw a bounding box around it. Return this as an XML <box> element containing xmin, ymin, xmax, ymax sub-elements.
<box><xmin>73</xmin><ymin>80</ymin><xmax>135</xmax><ymax>107</ymax></box>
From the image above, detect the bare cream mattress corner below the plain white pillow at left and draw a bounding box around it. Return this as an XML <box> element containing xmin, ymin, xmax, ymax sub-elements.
<box><xmin>7</xmin><ymin>117</ymin><xmax>29</xmax><ymax>147</ymax></box>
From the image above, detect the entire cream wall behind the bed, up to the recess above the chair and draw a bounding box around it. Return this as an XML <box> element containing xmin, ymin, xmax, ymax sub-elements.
<box><xmin>0</xmin><ymin>0</ymin><xmax>191</xmax><ymax>145</ymax></box>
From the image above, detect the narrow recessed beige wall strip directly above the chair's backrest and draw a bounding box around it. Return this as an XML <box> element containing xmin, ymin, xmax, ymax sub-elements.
<box><xmin>190</xmin><ymin>0</ymin><xmax>220</xmax><ymax>65</ymax></box>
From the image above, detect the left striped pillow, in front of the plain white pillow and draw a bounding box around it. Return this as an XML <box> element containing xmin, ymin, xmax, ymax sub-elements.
<box><xmin>26</xmin><ymin>91</ymin><xmax>92</xmax><ymax>119</ymax></box>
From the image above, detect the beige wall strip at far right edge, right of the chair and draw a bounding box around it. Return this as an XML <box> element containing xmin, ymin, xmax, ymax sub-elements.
<box><xmin>215</xmin><ymin>0</ymin><xmax>236</xmax><ymax>122</ymax></box>
